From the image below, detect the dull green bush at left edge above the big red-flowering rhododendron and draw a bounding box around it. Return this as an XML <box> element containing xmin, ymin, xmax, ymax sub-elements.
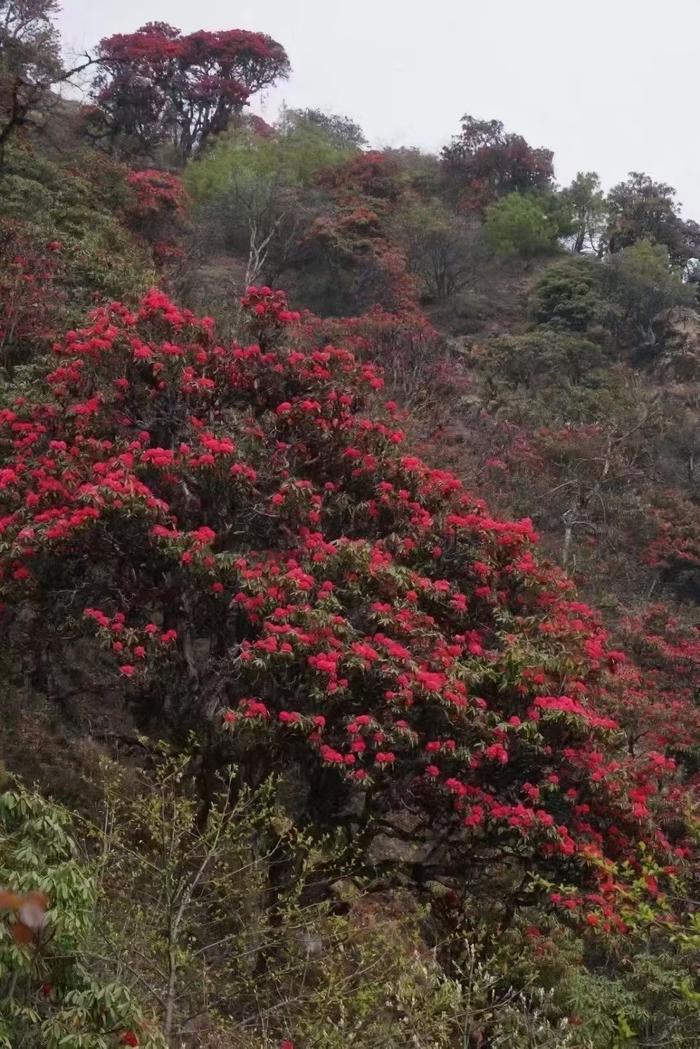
<box><xmin>0</xmin><ymin>143</ymin><xmax>154</xmax><ymax>365</ymax></box>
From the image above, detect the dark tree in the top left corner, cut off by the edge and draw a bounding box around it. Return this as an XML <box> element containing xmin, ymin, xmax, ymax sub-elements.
<box><xmin>0</xmin><ymin>0</ymin><xmax>63</xmax><ymax>156</ymax></box>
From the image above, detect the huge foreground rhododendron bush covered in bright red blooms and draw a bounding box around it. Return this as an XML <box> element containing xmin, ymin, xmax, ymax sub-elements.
<box><xmin>0</xmin><ymin>288</ymin><xmax>688</xmax><ymax>930</ymax></box>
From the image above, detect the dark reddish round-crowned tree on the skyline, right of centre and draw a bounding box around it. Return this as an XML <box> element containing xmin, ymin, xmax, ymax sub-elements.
<box><xmin>442</xmin><ymin>115</ymin><xmax>554</xmax><ymax>210</ymax></box>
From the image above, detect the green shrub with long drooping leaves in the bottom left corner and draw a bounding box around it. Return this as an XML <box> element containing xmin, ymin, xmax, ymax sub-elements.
<box><xmin>0</xmin><ymin>787</ymin><xmax>165</xmax><ymax>1049</ymax></box>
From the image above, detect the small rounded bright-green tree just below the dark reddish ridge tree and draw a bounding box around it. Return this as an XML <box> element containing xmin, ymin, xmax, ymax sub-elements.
<box><xmin>486</xmin><ymin>193</ymin><xmax>568</xmax><ymax>259</ymax></box>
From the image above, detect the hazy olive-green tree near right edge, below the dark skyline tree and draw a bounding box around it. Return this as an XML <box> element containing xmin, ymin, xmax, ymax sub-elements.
<box><xmin>606</xmin><ymin>240</ymin><xmax>695</xmax><ymax>345</ymax></box>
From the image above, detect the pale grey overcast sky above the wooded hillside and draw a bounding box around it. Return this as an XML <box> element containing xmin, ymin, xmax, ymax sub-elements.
<box><xmin>61</xmin><ymin>0</ymin><xmax>700</xmax><ymax>212</ymax></box>
